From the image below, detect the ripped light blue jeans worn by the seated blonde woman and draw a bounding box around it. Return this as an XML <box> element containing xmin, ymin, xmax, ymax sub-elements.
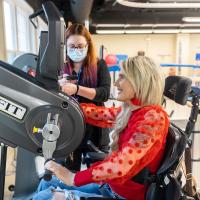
<box><xmin>33</xmin><ymin>176</ymin><xmax>124</xmax><ymax>200</ymax></box>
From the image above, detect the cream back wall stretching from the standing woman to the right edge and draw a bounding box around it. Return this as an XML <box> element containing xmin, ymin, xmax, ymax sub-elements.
<box><xmin>93</xmin><ymin>34</ymin><xmax>200</xmax><ymax>76</ymax></box>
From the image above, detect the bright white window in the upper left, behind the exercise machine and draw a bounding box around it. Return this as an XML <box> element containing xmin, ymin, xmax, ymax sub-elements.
<box><xmin>3</xmin><ymin>0</ymin><xmax>47</xmax><ymax>63</ymax></box>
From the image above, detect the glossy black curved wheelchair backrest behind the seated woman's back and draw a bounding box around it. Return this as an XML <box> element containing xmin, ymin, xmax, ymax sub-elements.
<box><xmin>157</xmin><ymin>126</ymin><xmax>187</xmax><ymax>175</ymax></box>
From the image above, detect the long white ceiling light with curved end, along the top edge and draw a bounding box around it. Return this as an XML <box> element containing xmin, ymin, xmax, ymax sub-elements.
<box><xmin>116</xmin><ymin>0</ymin><xmax>200</xmax><ymax>8</ymax></box>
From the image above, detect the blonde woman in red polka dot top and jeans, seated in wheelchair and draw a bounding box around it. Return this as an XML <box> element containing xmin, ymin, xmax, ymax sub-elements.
<box><xmin>34</xmin><ymin>56</ymin><xmax>169</xmax><ymax>200</ymax></box>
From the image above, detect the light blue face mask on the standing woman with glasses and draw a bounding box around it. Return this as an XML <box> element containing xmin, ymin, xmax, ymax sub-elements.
<box><xmin>67</xmin><ymin>46</ymin><xmax>88</xmax><ymax>62</ymax></box>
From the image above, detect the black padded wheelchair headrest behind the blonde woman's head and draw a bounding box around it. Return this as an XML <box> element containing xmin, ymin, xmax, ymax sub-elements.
<box><xmin>164</xmin><ymin>76</ymin><xmax>192</xmax><ymax>105</ymax></box>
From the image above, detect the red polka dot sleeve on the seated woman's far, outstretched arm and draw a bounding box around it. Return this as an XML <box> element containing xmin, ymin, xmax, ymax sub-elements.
<box><xmin>80</xmin><ymin>103</ymin><xmax>121</xmax><ymax>128</ymax></box>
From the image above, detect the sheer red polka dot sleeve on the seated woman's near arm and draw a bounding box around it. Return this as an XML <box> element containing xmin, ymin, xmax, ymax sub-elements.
<box><xmin>76</xmin><ymin>109</ymin><xmax>169</xmax><ymax>187</ymax></box>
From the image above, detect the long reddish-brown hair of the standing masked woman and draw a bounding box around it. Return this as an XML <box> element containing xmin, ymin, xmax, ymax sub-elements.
<box><xmin>65</xmin><ymin>23</ymin><xmax>97</xmax><ymax>87</ymax></box>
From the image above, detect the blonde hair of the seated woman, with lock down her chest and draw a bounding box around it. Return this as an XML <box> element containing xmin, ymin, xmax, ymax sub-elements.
<box><xmin>111</xmin><ymin>56</ymin><xmax>164</xmax><ymax>151</ymax></box>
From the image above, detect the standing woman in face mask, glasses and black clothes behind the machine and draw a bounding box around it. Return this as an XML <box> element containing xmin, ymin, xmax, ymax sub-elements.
<box><xmin>61</xmin><ymin>24</ymin><xmax>111</xmax><ymax>171</ymax></box>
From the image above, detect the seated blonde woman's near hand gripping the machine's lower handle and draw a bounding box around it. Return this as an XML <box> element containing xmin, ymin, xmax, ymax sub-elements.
<box><xmin>45</xmin><ymin>160</ymin><xmax>75</xmax><ymax>186</ymax></box>
